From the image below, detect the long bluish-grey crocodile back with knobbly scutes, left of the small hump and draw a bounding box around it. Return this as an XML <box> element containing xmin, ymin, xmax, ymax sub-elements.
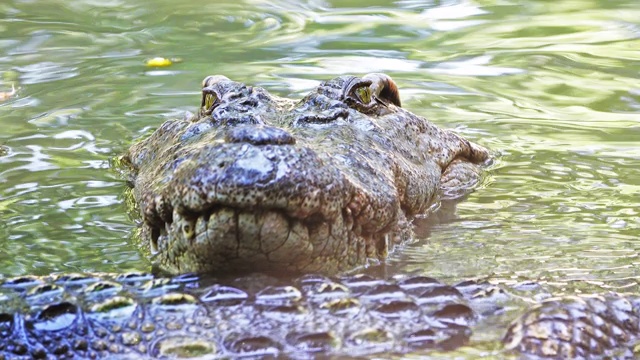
<box><xmin>0</xmin><ymin>274</ymin><xmax>499</xmax><ymax>359</ymax></box>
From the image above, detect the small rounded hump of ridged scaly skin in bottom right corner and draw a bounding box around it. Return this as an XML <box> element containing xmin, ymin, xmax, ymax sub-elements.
<box><xmin>503</xmin><ymin>294</ymin><xmax>640</xmax><ymax>359</ymax></box>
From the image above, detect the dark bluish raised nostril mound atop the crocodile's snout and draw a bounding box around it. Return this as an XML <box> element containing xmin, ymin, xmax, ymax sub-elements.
<box><xmin>224</xmin><ymin>125</ymin><xmax>296</xmax><ymax>145</ymax></box>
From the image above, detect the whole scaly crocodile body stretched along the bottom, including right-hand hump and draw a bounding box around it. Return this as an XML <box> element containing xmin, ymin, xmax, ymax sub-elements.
<box><xmin>0</xmin><ymin>274</ymin><xmax>640</xmax><ymax>360</ymax></box>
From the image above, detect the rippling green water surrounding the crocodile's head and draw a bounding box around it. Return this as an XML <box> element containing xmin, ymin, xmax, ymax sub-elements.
<box><xmin>0</xmin><ymin>0</ymin><xmax>640</xmax><ymax>298</ymax></box>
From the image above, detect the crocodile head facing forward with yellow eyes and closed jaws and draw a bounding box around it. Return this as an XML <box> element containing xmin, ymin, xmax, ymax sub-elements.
<box><xmin>123</xmin><ymin>74</ymin><xmax>490</xmax><ymax>273</ymax></box>
